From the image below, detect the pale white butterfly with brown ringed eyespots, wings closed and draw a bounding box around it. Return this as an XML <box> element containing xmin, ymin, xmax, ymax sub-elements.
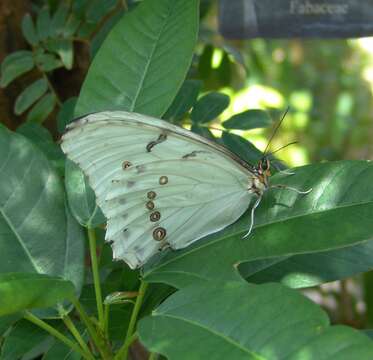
<box><xmin>61</xmin><ymin>111</ymin><xmax>308</xmax><ymax>268</ymax></box>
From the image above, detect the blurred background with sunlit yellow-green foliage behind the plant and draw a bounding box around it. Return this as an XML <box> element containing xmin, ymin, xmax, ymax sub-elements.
<box><xmin>0</xmin><ymin>0</ymin><xmax>373</xmax><ymax>327</ymax></box>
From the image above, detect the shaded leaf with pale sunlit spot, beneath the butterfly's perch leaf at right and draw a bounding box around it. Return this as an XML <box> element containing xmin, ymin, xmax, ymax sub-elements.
<box><xmin>239</xmin><ymin>241</ymin><xmax>373</xmax><ymax>288</ymax></box>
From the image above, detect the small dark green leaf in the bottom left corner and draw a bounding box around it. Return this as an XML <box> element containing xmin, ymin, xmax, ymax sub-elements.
<box><xmin>1</xmin><ymin>320</ymin><xmax>50</xmax><ymax>360</ymax></box>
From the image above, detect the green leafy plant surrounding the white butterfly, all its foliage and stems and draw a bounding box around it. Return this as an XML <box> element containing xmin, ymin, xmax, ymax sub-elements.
<box><xmin>0</xmin><ymin>0</ymin><xmax>373</xmax><ymax>360</ymax></box>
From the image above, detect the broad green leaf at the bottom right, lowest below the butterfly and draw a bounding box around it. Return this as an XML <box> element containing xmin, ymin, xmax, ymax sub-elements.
<box><xmin>138</xmin><ymin>282</ymin><xmax>373</xmax><ymax>360</ymax></box>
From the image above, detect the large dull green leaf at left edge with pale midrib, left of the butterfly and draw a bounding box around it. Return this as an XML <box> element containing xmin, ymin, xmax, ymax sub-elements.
<box><xmin>0</xmin><ymin>126</ymin><xmax>84</xmax><ymax>298</ymax></box>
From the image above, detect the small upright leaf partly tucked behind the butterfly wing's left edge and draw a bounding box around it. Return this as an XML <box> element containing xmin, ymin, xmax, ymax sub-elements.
<box><xmin>65</xmin><ymin>159</ymin><xmax>106</xmax><ymax>227</ymax></box>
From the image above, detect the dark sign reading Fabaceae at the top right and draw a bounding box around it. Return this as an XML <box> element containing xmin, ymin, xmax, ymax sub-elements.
<box><xmin>219</xmin><ymin>0</ymin><xmax>373</xmax><ymax>39</ymax></box>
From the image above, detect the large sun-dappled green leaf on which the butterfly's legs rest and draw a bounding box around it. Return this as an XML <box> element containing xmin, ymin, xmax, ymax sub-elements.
<box><xmin>144</xmin><ymin>161</ymin><xmax>373</xmax><ymax>287</ymax></box>
